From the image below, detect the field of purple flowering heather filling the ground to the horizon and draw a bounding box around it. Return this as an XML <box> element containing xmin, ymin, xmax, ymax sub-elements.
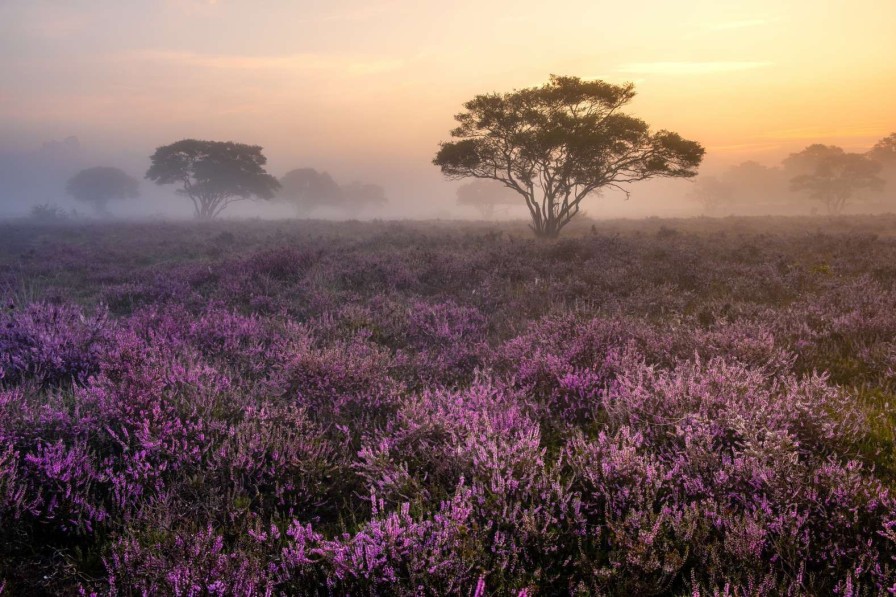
<box><xmin>0</xmin><ymin>216</ymin><xmax>896</xmax><ymax>597</ymax></box>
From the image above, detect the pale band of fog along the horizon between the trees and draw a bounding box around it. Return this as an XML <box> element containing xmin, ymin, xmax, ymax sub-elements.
<box><xmin>0</xmin><ymin>136</ymin><xmax>896</xmax><ymax>220</ymax></box>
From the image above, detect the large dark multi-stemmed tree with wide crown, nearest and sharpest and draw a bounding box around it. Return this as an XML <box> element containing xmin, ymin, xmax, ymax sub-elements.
<box><xmin>433</xmin><ymin>75</ymin><xmax>704</xmax><ymax>238</ymax></box>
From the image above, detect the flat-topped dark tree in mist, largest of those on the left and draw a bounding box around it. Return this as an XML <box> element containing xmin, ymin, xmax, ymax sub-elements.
<box><xmin>146</xmin><ymin>139</ymin><xmax>280</xmax><ymax>220</ymax></box>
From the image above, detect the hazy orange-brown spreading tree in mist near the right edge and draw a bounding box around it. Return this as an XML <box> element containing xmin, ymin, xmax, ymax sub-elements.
<box><xmin>784</xmin><ymin>144</ymin><xmax>884</xmax><ymax>215</ymax></box>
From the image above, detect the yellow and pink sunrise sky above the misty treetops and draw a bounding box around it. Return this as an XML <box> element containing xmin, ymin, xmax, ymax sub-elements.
<box><xmin>0</xmin><ymin>0</ymin><xmax>896</xmax><ymax>215</ymax></box>
